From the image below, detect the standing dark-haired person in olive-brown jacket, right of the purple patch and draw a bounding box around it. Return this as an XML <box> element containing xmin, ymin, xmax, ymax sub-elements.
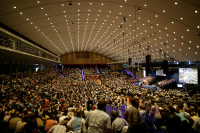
<box><xmin>128</xmin><ymin>98</ymin><xmax>146</xmax><ymax>133</ymax></box>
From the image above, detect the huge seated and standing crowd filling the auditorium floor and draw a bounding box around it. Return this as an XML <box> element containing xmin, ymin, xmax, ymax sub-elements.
<box><xmin>0</xmin><ymin>69</ymin><xmax>200</xmax><ymax>133</ymax></box>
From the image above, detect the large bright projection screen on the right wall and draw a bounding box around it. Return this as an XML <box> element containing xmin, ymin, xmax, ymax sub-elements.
<box><xmin>179</xmin><ymin>68</ymin><xmax>198</xmax><ymax>84</ymax></box>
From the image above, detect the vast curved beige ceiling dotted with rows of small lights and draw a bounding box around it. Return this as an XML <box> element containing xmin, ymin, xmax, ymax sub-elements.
<box><xmin>0</xmin><ymin>0</ymin><xmax>200</xmax><ymax>63</ymax></box>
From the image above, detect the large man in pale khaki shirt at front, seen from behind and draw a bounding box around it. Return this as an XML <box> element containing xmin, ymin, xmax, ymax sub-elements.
<box><xmin>85</xmin><ymin>100</ymin><xmax>111</xmax><ymax>133</ymax></box>
